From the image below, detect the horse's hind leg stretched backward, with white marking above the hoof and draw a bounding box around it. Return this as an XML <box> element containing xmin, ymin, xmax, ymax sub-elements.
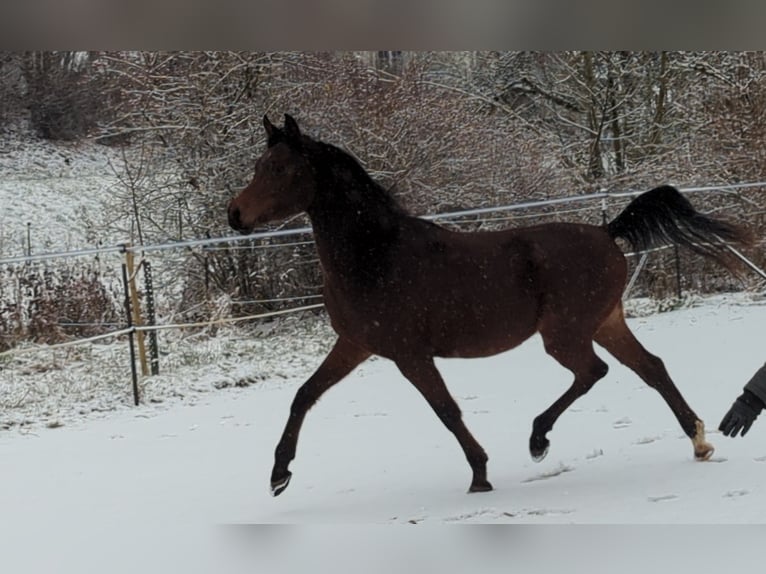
<box><xmin>595</xmin><ymin>305</ymin><xmax>714</xmax><ymax>460</ymax></box>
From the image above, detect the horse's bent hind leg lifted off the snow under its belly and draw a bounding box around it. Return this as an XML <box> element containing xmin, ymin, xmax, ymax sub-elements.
<box><xmin>529</xmin><ymin>325</ymin><xmax>609</xmax><ymax>462</ymax></box>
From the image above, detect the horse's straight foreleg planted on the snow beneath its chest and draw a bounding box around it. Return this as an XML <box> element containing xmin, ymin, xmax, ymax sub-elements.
<box><xmin>396</xmin><ymin>358</ymin><xmax>492</xmax><ymax>492</ymax></box>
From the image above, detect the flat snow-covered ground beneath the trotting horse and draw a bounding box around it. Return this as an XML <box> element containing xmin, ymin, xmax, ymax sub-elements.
<box><xmin>0</xmin><ymin>295</ymin><xmax>766</xmax><ymax>573</ymax></box>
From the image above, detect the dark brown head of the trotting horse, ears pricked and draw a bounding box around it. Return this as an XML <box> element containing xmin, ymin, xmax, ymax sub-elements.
<box><xmin>229</xmin><ymin>114</ymin><xmax>316</xmax><ymax>233</ymax></box>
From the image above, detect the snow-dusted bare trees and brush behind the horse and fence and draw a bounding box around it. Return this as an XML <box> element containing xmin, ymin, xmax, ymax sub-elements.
<box><xmin>0</xmin><ymin>51</ymin><xmax>766</xmax><ymax>348</ymax></box>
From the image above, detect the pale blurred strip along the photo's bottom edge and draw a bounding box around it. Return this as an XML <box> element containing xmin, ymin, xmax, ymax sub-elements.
<box><xmin>3</xmin><ymin>528</ymin><xmax>766</xmax><ymax>574</ymax></box>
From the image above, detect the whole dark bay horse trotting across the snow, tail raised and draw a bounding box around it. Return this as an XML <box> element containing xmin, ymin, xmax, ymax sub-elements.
<box><xmin>228</xmin><ymin>115</ymin><xmax>749</xmax><ymax>496</ymax></box>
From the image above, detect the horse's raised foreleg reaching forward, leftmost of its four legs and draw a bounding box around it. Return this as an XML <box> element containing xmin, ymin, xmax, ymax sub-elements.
<box><xmin>271</xmin><ymin>338</ymin><xmax>370</xmax><ymax>496</ymax></box>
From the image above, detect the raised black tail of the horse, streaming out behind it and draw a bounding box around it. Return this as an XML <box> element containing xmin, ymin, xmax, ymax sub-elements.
<box><xmin>607</xmin><ymin>185</ymin><xmax>752</xmax><ymax>270</ymax></box>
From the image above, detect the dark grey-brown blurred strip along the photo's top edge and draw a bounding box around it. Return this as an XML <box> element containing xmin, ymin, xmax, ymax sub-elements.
<box><xmin>0</xmin><ymin>0</ymin><xmax>766</xmax><ymax>50</ymax></box>
